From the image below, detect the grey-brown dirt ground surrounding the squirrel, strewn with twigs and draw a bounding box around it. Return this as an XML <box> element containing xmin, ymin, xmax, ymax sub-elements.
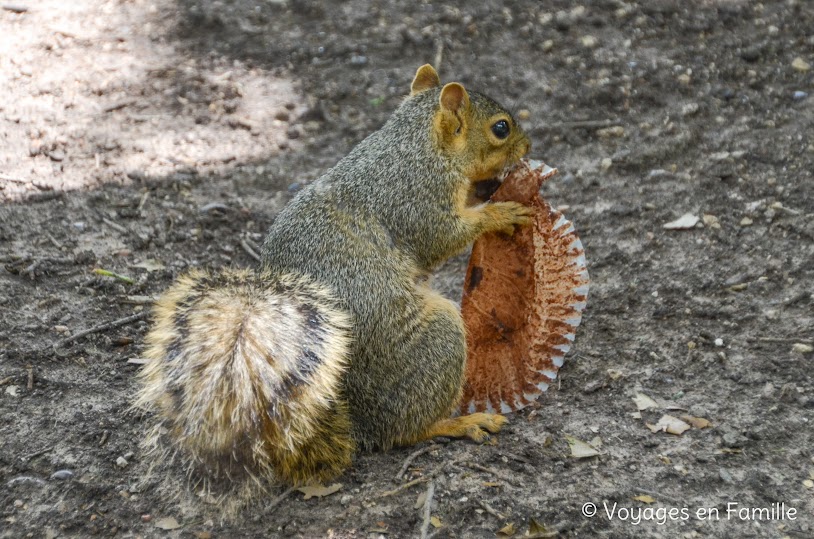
<box><xmin>0</xmin><ymin>0</ymin><xmax>814</xmax><ymax>538</ymax></box>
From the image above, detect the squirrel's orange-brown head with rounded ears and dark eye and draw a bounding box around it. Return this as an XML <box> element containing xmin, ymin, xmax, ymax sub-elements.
<box><xmin>410</xmin><ymin>64</ymin><xmax>531</xmax><ymax>181</ymax></box>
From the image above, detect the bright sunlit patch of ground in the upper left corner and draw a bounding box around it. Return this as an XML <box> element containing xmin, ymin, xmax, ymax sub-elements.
<box><xmin>0</xmin><ymin>0</ymin><xmax>305</xmax><ymax>200</ymax></box>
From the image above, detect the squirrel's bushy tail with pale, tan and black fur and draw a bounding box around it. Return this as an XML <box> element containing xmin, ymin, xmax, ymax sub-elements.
<box><xmin>136</xmin><ymin>270</ymin><xmax>353</xmax><ymax>484</ymax></box>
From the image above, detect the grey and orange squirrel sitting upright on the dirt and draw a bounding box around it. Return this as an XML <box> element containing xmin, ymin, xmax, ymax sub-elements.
<box><xmin>136</xmin><ymin>64</ymin><xmax>532</xmax><ymax>492</ymax></box>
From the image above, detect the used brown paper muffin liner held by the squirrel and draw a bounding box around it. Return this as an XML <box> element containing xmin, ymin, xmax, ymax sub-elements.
<box><xmin>461</xmin><ymin>161</ymin><xmax>588</xmax><ymax>413</ymax></box>
